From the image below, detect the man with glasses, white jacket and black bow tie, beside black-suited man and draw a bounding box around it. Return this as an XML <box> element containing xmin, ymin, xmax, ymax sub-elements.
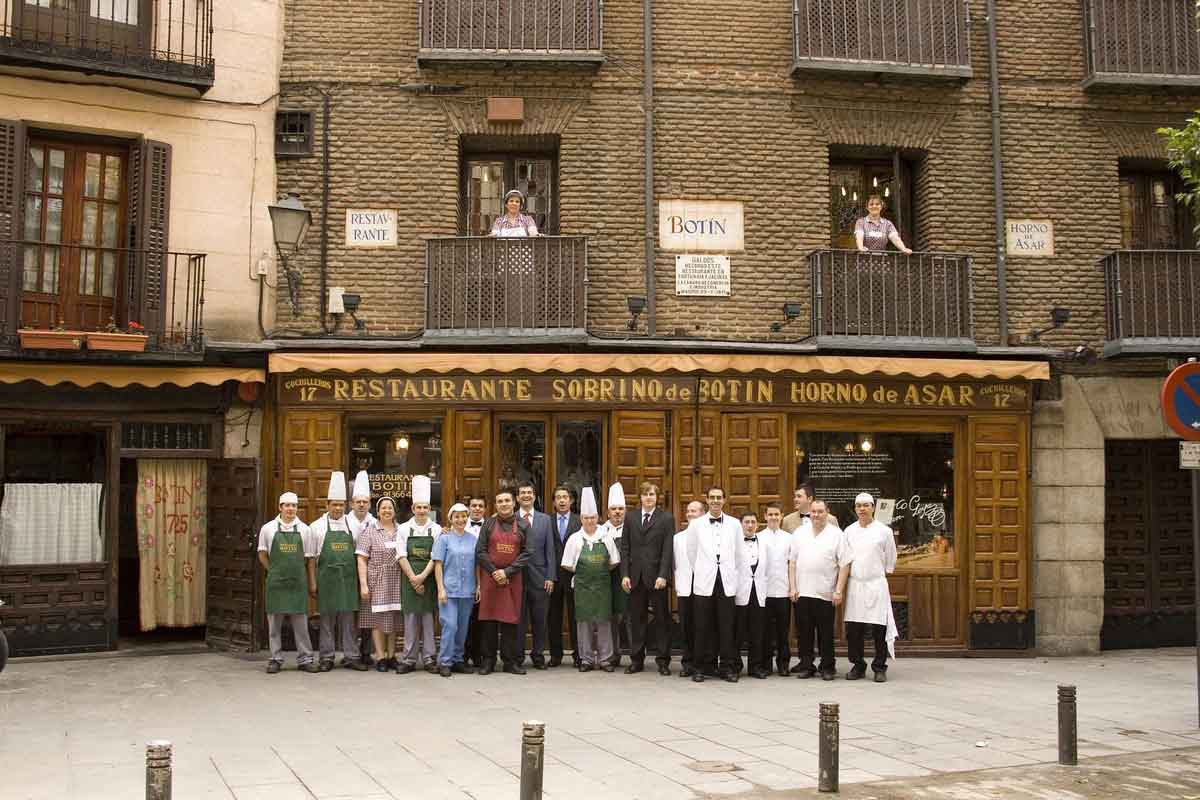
<box><xmin>688</xmin><ymin>486</ymin><xmax>742</xmax><ymax>684</ymax></box>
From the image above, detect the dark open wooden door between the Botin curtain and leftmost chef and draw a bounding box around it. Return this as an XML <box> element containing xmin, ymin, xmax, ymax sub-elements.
<box><xmin>204</xmin><ymin>458</ymin><xmax>263</xmax><ymax>652</ymax></box>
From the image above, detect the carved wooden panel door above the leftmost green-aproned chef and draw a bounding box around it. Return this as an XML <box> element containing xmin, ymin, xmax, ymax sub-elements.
<box><xmin>283</xmin><ymin>411</ymin><xmax>344</xmax><ymax>522</ymax></box>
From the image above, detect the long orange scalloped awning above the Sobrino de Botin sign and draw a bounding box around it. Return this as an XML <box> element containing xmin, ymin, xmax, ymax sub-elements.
<box><xmin>268</xmin><ymin>353</ymin><xmax>1050</xmax><ymax>380</ymax></box>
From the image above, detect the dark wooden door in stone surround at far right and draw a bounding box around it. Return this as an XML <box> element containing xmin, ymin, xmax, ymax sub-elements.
<box><xmin>1100</xmin><ymin>439</ymin><xmax>1195</xmax><ymax>650</ymax></box>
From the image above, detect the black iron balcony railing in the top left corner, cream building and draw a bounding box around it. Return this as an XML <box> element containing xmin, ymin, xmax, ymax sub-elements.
<box><xmin>0</xmin><ymin>0</ymin><xmax>215</xmax><ymax>92</ymax></box>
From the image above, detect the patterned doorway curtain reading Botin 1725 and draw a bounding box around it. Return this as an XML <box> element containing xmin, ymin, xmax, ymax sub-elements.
<box><xmin>137</xmin><ymin>458</ymin><xmax>209</xmax><ymax>631</ymax></box>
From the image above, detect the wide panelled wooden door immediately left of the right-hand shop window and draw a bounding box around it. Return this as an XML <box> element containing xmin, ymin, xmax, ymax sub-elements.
<box><xmin>721</xmin><ymin>413</ymin><xmax>787</xmax><ymax>519</ymax></box>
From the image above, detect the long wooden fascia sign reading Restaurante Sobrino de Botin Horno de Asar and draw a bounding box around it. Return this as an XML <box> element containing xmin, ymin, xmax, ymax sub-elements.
<box><xmin>280</xmin><ymin>373</ymin><xmax>1030</xmax><ymax>410</ymax></box>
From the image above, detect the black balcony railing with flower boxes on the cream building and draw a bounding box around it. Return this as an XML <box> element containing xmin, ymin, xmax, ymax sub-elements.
<box><xmin>0</xmin><ymin>241</ymin><xmax>205</xmax><ymax>354</ymax></box>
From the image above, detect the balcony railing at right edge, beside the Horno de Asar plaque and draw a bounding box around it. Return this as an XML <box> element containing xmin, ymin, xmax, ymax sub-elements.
<box><xmin>1100</xmin><ymin>249</ymin><xmax>1200</xmax><ymax>355</ymax></box>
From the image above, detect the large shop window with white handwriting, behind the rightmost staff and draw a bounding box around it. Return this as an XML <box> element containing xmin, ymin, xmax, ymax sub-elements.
<box><xmin>794</xmin><ymin>431</ymin><xmax>956</xmax><ymax>570</ymax></box>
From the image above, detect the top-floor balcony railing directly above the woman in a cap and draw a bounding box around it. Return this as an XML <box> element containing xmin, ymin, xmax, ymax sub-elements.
<box><xmin>416</xmin><ymin>0</ymin><xmax>604</xmax><ymax>64</ymax></box>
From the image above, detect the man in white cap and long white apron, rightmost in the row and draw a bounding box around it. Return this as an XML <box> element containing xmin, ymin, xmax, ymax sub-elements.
<box><xmin>845</xmin><ymin>492</ymin><xmax>898</xmax><ymax>684</ymax></box>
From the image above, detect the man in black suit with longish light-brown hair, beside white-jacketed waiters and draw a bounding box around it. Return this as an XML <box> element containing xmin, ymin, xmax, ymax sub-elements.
<box><xmin>617</xmin><ymin>482</ymin><xmax>676</xmax><ymax>675</ymax></box>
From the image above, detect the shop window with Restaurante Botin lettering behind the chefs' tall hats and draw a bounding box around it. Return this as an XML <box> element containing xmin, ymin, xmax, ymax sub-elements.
<box><xmin>350</xmin><ymin>419</ymin><xmax>449</xmax><ymax>523</ymax></box>
